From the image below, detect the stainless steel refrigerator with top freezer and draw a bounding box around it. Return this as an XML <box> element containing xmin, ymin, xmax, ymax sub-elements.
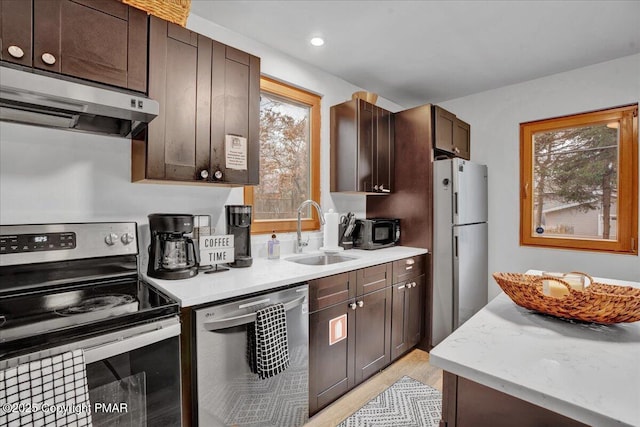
<box><xmin>431</xmin><ymin>158</ymin><xmax>488</xmax><ymax>346</ymax></box>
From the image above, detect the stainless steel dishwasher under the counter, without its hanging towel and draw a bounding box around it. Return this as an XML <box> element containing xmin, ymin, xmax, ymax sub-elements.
<box><xmin>193</xmin><ymin>284</ymin><xmax>309</xmax><ymax>427</ymax></box>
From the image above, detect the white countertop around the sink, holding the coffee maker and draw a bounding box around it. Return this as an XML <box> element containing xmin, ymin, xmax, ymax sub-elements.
<box><xmin>144</xmin><ymin>246</ymin><xmax>427</xmax><ymax>307</ymax></box>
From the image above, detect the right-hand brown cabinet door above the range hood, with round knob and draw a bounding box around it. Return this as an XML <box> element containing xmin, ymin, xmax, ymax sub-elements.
<box><xmin>33</xmin><ymin>0</ymin><xmax>147</xmax><ymax>92</ymax></box>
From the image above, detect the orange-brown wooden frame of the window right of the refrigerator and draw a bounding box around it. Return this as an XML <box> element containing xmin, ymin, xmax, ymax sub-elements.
<box><xmin>520</xmin><ymin>104</ymin><xmax>638</xmax><ymax>255</ymax></box>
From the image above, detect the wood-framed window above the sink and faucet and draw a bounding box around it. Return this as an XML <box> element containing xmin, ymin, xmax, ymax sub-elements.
<box><xmin>244</xmin><ymin>77</ymin><xmax>320</xmax><ymax>233</ymax></box>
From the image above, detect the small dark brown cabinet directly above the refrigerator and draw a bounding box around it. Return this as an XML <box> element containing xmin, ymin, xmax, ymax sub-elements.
<box><xmin>433</xmin><ymin>105</ymin><xmax>471</xmax><ymax>160</ymax></box>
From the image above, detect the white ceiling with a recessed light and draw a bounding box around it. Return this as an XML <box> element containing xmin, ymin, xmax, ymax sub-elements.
<box><xmin>191</xmin><ymin>0</ymin><xmax>640</xmax><ymax>107</ymax></box>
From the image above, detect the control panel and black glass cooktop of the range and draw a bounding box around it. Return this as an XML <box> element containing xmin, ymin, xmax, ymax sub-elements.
<box><xmin>0</xmin><ymin>222</ymin><xmax>179</xmax><ymax>361</ymax></box>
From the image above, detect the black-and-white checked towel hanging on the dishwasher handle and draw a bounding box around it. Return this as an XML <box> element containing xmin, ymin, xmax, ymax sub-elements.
<box><xmin>255</xmin><ymin>304</ymin><xmax>289</xmax><ymax>379</ymax></box>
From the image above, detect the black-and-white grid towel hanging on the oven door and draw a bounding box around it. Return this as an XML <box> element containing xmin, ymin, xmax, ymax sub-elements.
<box><xmin>0</xmin><ymin>350</ymin><xmax>91</xmax><ymax>427</ymax></box>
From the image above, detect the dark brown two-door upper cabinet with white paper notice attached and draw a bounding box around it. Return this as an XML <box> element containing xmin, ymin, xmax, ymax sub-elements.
<box><xmin>132</xmin><ymin>17</ymin><xmax>260</xmax><ymax>185</ymax></box>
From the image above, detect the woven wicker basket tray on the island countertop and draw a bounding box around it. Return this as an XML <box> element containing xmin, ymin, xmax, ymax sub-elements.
<box><xmin>493</xmin><ymin>273</ymin><xmax>640</xmax><ymax>324</ymax></box>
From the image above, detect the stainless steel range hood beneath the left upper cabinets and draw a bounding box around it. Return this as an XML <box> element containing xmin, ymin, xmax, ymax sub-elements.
<box><xmin>0</xmin><ymin>66</ymin><xmax>160</xmax><ymax>137</ymax></box>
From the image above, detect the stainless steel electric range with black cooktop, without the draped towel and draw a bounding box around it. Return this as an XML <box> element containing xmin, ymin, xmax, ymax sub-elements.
<box><xmin>0</xmin><ymin>222</ymin><xmax>181</xmax><ymax>426</ymax></box>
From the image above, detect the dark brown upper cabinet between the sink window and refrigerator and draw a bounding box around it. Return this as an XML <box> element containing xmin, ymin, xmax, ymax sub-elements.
<box><xmin>331</xmin><ymin>99</ymin><xmax>394</xmax><ymax>194</ymax></box>
